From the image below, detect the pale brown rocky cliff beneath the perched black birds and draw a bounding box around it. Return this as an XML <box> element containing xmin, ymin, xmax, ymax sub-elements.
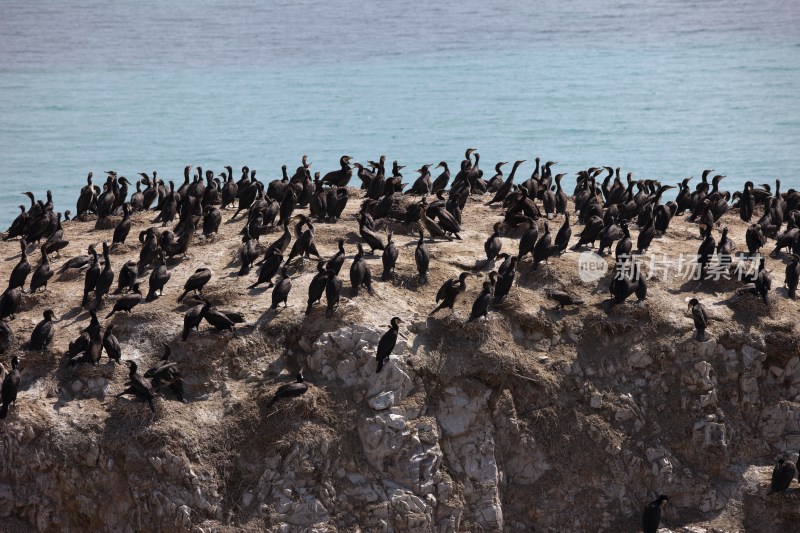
<box><xmin>0</xmin><ymin>190</ymin><xmax>800</xmax><ymax>533</ymax></box>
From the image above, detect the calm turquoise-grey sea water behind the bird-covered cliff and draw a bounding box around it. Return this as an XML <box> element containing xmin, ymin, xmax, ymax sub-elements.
<box><xmin>0</xmin><ymin>0</ymin><xmax>800</xmax><ymax>226</ymax></box>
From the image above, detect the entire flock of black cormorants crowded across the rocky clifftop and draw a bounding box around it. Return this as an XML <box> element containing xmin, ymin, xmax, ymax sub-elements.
<box><xmin>0</xmin><ymin>149</ymin><xmax>800</xmax><ymax>531</ymax></box>
